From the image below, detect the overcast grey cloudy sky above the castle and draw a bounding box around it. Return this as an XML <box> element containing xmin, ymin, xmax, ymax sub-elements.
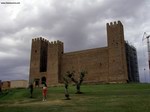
<box><xmin>0</xmin><ymin>0</ymin><xmax>150</xmax><ymax>81</ymax></box>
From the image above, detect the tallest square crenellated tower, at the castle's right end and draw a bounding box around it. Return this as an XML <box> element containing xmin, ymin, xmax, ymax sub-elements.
<box><xmin>107</xmin><ymin>21</ymin><xmax>128</xmax><ymax>82</ymax></box>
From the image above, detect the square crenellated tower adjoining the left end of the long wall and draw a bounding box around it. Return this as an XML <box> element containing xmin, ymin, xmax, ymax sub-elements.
<box><xmin>47</xmin><ymin>40</ymin><xmax>64</xmax><ymax>85</ymax></box>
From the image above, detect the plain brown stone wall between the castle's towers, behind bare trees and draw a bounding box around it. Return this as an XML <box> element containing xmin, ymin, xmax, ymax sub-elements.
<box><xmin>61</xmin><ymin>48</ymin><xmax>108</xmax><ymax>82</ymax></box>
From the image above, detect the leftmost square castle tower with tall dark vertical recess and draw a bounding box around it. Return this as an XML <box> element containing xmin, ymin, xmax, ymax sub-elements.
<box><xmin>29</xmin><ymin>37</ymin><xmax>49</xmax><ymax>86</ymax></box>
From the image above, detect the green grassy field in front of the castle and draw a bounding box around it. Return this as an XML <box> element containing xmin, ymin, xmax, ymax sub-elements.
<box><xmin>0</xmin><ymin>84</ymin><xmax>150</xmax><ymax>112</ymax></box>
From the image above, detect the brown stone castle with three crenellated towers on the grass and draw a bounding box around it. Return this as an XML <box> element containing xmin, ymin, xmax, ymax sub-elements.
<box><xmin>29</xmin><ymin>21</ymin><xmax>139</xmax><ymax>85</ymax></box>
